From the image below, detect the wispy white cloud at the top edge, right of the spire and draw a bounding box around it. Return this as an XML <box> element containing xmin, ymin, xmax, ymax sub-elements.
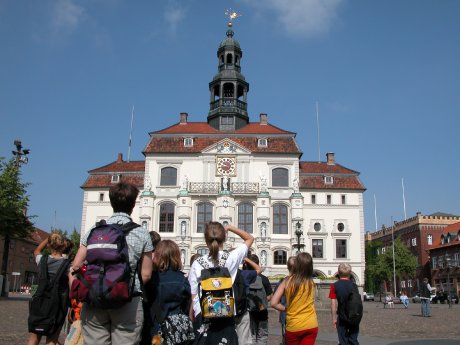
<box><xmin>245</xmin><ymin>0</ymin><xmax>343</xmax><ymax>37</ymax></box>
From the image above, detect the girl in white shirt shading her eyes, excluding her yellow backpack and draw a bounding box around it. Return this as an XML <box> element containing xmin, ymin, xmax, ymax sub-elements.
<box><xmin>188</xmin><ymin>222</ymin><xmax>254</xmax><ymax>345</ymax></box>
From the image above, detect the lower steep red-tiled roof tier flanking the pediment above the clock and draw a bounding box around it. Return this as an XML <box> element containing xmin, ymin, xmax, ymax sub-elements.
<box><xmin>144</xmin><ymin>137</ymin><xmax>301</xmax><ymax>154</ymax></box>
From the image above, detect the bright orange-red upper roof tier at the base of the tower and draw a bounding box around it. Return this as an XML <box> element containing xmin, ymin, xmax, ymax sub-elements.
<box><xmin>150</xmin><ymin>122</ymin><xmax>292</xmax><ymax>135</ymax></box>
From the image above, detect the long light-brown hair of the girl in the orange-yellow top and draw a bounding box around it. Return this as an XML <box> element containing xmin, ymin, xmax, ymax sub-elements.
<box><xmin>286</xmin><ymin>253</ymin><xmax>313</xmax><ymax>294</ymax></box>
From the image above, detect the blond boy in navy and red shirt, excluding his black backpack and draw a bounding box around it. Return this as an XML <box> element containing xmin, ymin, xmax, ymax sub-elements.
<box><xmin>329</xmin><ymin>263</ymin><xmax>359</xmax><ymax>345</ymax></box>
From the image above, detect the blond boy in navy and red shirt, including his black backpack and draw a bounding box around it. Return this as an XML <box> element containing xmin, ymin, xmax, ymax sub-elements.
<box><xmin>329</xmin><ymin>263</ymin><xmax>363</xmax><ymax>345</ymax></box>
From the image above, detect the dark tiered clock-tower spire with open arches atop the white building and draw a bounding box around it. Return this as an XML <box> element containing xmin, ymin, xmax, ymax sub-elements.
<box><xmin>208</xmin><ymin>20</ymin><xmax>249</xmax><ymax>131</ymax></box>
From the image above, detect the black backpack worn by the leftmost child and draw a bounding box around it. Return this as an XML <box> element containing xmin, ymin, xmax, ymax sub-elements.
<box><xmin>28</xmin><ymin>255</ymin><xmax>70</xmax><ymax>335</ymax></box>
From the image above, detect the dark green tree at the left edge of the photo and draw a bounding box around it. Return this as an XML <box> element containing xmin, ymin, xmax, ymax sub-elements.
<box><xmin>0</xmin><ymin>157</ymin><xmax>33</xmax><ymax>238</ymax></box>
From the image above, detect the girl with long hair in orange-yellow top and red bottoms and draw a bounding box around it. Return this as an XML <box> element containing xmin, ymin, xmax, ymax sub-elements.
<box><xmin>271</xmin><ymin>253</ymin><xmax>318</xmax><ymax>345</ymax></box>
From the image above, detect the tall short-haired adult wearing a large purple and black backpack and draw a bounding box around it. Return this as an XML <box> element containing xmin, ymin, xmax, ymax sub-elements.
<box><xmin>71</xmin><ymin>182</ymin><xmax>153</xmax><ymax>345</ymax></box>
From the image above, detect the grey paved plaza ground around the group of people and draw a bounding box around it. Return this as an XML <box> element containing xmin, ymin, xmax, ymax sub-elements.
<box><xmin>0</xmin><ymin>296</ymin><xmax>460</xmax><ymax>345</ymax></box>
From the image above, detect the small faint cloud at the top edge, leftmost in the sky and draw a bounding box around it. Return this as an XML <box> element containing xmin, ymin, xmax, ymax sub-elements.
<box><xmin>52</xmin><ymin>0</ymin><xmax>85</xmax><ymax>32</ymax></box>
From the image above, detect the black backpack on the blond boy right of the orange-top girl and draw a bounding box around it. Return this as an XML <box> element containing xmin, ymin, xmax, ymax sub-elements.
<box><xmin>335</xmin><ymin>280</ymin><xmax>363</xmax><ymax>326</ymax></box>
